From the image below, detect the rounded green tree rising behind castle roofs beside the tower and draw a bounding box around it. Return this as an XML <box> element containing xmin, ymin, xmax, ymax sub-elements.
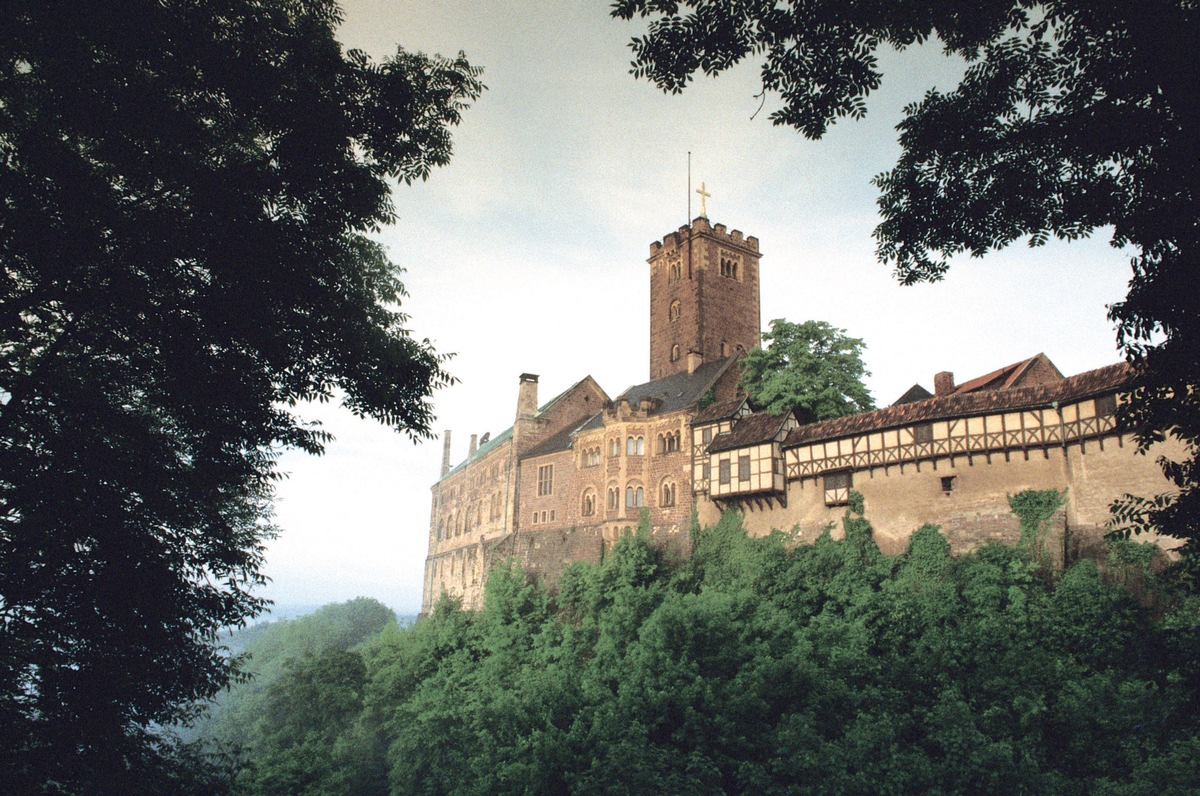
<box><xmin>742</xmin><ymin>318</ymin><xmax>875</xmax><ymax>423</ymax></box>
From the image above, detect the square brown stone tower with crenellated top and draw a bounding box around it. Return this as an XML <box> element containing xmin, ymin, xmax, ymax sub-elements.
<box><xmin>648</xmin><ymin>216</ymin><xmax>762</xmax><ymax>379</ymax></box>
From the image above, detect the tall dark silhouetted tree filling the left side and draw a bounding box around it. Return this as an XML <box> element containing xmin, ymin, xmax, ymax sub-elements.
<box><xmin>0</xmin><ymin>0</ymin><xmax>482</xmax><ymax>792</ymax></box>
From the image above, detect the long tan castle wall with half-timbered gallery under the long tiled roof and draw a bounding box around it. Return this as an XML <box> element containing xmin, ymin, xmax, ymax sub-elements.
<box><xmin>697</xmin><ymin>395</ymin><xmax>1171</xmax><ymax>559</ymax></box>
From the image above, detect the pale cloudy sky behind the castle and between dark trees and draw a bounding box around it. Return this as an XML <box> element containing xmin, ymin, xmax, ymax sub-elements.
<box><xmin>262</xmin><ymin>0</ymin><xmax>1130</xmax><ymax>614</ymax></box>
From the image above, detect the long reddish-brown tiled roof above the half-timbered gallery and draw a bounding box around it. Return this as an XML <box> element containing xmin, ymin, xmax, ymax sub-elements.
<box><xmin>784</xmin><ymin>360</ymin><xmax>1133</xmax><ymax>447</ymax></box>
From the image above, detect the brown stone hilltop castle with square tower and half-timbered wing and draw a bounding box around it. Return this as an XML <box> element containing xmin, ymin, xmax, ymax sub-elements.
<box><xmin>421</xmin><ymin>215</ymin><xmax>1168</xmax><ymax>612</ymax></box>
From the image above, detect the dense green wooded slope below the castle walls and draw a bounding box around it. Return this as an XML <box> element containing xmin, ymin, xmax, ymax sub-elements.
<box><xmin>196</xmin><ymin>501</ymin><xmax>1200</xmax><ymax>794</ymax></box>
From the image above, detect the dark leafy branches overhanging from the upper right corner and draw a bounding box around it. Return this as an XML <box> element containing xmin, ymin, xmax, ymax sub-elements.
<box><xmin>613</xmin><ymin>0</ymin><xmax>1200</xmax><ymax>564</ymax></box>
